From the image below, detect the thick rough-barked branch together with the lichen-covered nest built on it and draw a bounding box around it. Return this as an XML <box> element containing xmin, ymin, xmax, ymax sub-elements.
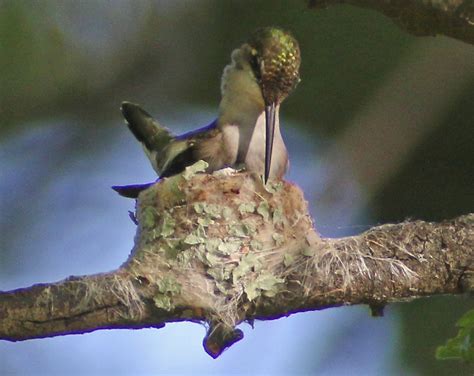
<box><xmin>0</xmin><ymin>169</ymin><xmax>474</xmax><ymax>357</ymax></box>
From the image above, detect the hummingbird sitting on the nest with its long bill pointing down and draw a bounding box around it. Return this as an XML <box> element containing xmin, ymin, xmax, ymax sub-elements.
<box><xmin>112</xmin><ymin>27</ymin><xmax>301</xmax><ymax>198</ymax></box>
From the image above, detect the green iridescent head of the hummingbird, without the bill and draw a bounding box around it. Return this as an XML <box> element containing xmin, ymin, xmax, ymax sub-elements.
<box><xmin>247</xmin><ymin>27</ymin><xmax>301</xmax><ymax>105</ymax></box>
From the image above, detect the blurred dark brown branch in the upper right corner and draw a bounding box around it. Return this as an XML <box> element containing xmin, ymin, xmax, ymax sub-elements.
<box><xmin>309</xmin><ymin>0</ymin><xmax>474</xmax><ymax>44</ymax></box>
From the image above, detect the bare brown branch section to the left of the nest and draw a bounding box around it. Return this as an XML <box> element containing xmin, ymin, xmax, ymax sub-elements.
<box><xmin>0</xmin><ymin>270</ymin><xmax>168</xmax><ymax>341</ymax></box>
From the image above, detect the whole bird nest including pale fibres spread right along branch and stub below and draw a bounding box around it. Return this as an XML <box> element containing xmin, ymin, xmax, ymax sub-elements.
<box><xmin>110</xmin><ymin>161</ymin><xmax>416</xmax><ymax>356</ymax></box>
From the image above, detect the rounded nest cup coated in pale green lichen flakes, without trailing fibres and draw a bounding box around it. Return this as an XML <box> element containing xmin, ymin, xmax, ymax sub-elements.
<box><xmin>120</xmin><ymin>162</ymin><xmax>311</xmax><ymax>327</ymax></box>
